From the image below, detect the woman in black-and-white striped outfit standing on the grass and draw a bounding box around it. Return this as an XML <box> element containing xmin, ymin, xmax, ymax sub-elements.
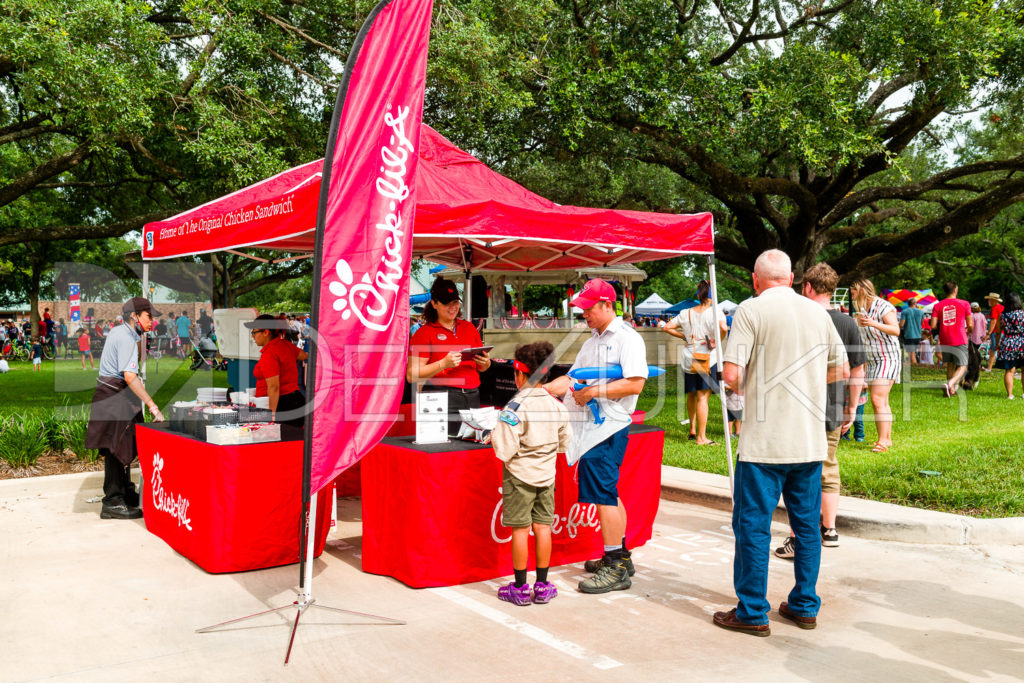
<box><xmin>850</xmin><ymin>280</ymin><xmax>902</xmax><ymax>453</ymax></box>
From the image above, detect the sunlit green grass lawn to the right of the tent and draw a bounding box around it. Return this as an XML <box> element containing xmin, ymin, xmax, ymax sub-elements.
<box><xmin>639</xmin><ymin>368</ymin><xmax>1024</xmax><ymax>517</ymax></box>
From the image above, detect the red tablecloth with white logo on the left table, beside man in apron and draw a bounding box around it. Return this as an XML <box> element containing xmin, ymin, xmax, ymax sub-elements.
<box><xmin>136</xmin><ymin>425</ymin><xmax>334</xmax><ymax>573</ymax></box>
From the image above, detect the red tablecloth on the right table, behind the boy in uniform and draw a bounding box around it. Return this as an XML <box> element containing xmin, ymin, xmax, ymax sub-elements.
<box><xmin>361</xmin><ymin>426</ymin><xmax>665</xmax><ymax>588</ymax></box>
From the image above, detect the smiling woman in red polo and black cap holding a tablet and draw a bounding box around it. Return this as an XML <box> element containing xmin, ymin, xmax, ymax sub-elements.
<box><xmin>406</xmin><ymin>278</ymin><xmax>490</xmax><ymax>434</ymax></box>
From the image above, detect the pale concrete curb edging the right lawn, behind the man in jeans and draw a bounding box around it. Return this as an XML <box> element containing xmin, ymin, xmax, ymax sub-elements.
<box><xmin>662</xmin><ymin>465</ymin><xmax>1024</xmax><ymax>546</ymax></box>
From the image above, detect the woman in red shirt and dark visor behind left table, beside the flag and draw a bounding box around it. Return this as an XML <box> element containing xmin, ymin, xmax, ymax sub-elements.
<box><xmin>245</xmin><ymin>313</ymin><xmax>306</xmax><ymax>440</ymax></box>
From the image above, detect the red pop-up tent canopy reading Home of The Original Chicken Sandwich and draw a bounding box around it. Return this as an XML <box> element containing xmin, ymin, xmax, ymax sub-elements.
<box><xmin>142</xmin><ymin>126</ymin><xmax>714</xmax><ymax>271</ymax></box>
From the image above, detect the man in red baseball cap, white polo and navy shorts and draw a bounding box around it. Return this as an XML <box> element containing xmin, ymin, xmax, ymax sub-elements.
<box><xmin>546</xmin><ymin>280</ymin><xmax>647</xmax><ymax>593</ymax></box>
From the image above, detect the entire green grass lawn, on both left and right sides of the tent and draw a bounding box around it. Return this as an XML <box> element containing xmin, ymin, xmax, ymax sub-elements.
<box><xmin>0</xmin><ymin>358</ymin><xmax>1024</xmax><ymax>517</ymax></box>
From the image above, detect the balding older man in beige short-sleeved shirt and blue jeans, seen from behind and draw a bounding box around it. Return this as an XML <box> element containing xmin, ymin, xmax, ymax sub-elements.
<box><xmin>713</xmin><ymin>249</ymin><xmax>850</xmax><ymax>636</ymax></box>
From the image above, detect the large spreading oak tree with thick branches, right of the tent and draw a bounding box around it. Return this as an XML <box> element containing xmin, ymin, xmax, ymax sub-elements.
<box><xmin>433</xmin><ymin>0</ymin><xmax>1024</xmax><ymax>282</ymax></box>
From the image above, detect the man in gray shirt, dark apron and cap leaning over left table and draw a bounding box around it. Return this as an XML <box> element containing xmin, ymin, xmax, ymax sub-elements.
<box><xmin>85</xmin><ymin>297</ymin><xmax>164</xmax><ymax>519</ymax></box>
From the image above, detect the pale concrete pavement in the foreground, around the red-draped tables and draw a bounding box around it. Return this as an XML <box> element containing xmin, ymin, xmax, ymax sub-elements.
<box><xmin>6</xmin><ymin>474</ymin><xmax>1024</xmax><ymax>682</ymax></box>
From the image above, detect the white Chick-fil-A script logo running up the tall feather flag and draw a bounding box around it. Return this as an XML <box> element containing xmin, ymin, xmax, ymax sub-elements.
<box><xmin>328</xmin><ymin>102</ymin><xmax>416</xmax><ymax>332</ymax></box>
